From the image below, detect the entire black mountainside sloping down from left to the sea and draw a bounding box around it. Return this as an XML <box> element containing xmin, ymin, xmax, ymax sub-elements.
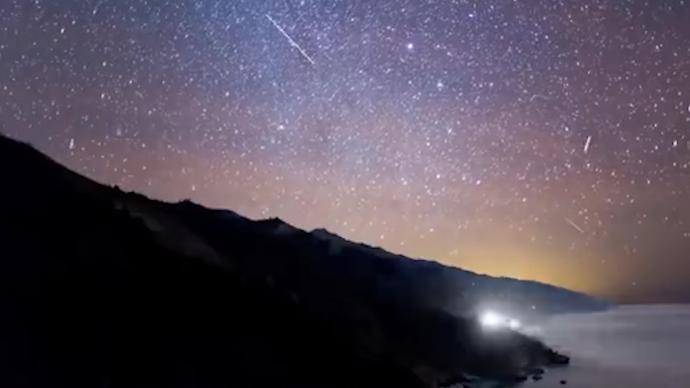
<box><xmin>0</xmin><ymin>136</ymin><xmax>605</xmax><ymax>388</ymax></box>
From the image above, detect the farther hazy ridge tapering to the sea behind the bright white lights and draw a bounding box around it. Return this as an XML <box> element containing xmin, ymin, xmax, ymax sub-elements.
<box><xmin>172</xmin><ymin>201</ymin><xmax>609</xmax><ymax>317</ymax></box>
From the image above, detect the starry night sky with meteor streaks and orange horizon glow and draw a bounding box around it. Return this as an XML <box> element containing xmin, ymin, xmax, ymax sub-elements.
<box><xmin>0</xmin><ymin>0</ymin><xmax>690</xmax><ymax>301</ymax></box>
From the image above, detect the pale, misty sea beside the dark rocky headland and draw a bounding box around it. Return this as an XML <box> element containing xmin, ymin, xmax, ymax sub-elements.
<box><xmin>519</xmin><ymin>305</ymin><xmax>690</xmax><ymax>388</ymax></box>
